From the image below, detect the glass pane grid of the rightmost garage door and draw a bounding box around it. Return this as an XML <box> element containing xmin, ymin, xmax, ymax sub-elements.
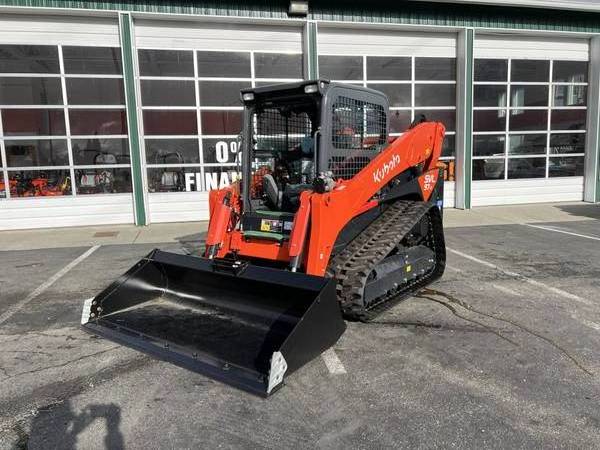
<box><xmin>473</xmin><ymin>59</ymin><xmax>588</xmax><ymax>180</ymax></box>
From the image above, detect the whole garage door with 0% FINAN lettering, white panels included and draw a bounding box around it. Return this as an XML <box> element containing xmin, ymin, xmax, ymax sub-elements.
<box><xmin>135</xmin><ymin>21</ymin><xmax>303</xmax><ymax>222</ymax></box>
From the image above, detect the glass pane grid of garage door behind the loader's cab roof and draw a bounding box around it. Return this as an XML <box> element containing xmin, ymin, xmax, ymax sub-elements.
<box><xmin>319</xmin><ymin>55</ymin><xmax>456</xmax><ymax>181</ymax></box>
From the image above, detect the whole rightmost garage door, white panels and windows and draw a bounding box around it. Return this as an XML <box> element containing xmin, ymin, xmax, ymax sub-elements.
<box><xmin>472</xmin><ymin>35</ymin><xmax>589</xmax><ymax>206</ymax></box>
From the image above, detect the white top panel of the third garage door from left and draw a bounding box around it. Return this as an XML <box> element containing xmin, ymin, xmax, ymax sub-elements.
<box><xmin>318</xmin><ymin>27</ymin><xmax>456</xmax><ymax>57</ymax></box>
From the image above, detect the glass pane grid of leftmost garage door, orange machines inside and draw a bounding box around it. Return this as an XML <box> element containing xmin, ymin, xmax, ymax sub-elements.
<box><xmin>0</xmin><ymin>45</ymin><xmax>131</xmax><ymax>198</ymax></box>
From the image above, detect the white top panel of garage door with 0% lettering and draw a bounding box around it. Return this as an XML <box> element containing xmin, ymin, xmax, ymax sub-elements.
<box><xmin>135</xmin><ymin>20</ymin><xmax>302</xmax><ymax>53</ymax></box>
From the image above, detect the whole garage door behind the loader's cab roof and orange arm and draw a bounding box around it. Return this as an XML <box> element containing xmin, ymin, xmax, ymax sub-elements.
<box><xmin>318</xmin><ymin>26</ymin><xmax>456</xmax><ymax>207</ymax></box>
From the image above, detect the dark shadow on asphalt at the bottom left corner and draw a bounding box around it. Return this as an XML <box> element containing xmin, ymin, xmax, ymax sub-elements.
<box><xmin>27</xmin><ymin>401</ymin><xmax>125</xmax><ymax>450</ymax></box>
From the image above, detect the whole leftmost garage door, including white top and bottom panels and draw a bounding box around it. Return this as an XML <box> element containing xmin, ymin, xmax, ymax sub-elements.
<box><xmin>0</xmin><ymin>14</ymin><xmax>134</xmax><ymax>229</ymax></box>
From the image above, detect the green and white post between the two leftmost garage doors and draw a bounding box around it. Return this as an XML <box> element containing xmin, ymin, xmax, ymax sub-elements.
<box><xmin>119</xmin><ymin>13</ymin><xmax>147</xmax><ymax>226</ymax></box>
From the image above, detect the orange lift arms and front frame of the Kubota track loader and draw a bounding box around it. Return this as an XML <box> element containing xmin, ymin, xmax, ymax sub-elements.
<box><xmin>207</xmin><ymin>122</ymin><xmax>445</xmax><ymax>276</ymax></box>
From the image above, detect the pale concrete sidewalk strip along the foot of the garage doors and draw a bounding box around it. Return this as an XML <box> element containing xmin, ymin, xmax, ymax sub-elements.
<box><xmin>0</xmin><ymin>202</ymin><xmax>600</xmax><ymax>250</ymax></box>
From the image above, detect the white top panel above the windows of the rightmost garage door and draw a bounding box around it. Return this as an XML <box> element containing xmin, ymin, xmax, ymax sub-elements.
<box><xmin>473</xmin><ymin>34</ymin><xmax>590</xmax><ymax>61</ymax></box>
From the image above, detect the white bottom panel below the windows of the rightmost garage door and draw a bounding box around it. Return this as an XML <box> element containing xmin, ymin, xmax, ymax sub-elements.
<box><xmin>472</xmin><ymin>177</ymin><xmax>583</xmax><ymax>206</ymax></box>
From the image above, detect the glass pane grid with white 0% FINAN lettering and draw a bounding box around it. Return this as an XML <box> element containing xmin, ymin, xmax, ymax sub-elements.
<box><xmin>138</xmin><ymin>49</ymin><xmax>302</xmax><ymax>192</ymax></box>
